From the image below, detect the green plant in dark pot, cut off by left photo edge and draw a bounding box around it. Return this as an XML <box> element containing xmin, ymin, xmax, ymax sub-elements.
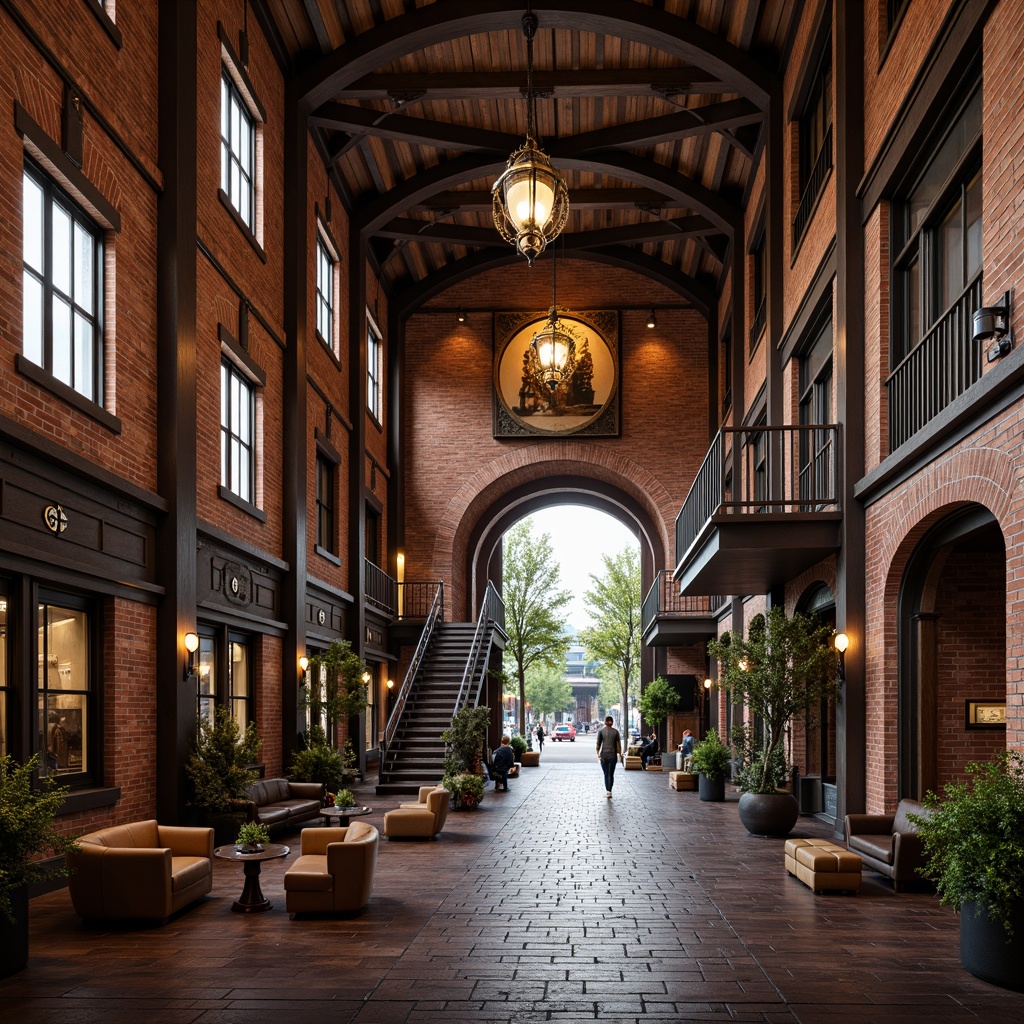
<box><xmin>0</xmin><ymin>754</ymin><xmax>78</xmax><ymax>978</ymax></box>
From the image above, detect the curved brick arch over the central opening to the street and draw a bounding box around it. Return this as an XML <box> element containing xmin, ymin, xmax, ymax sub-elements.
<box><xmin>431</xmin><ymin>439</ymin><xmax>678</xmax><ymax>608</ymax></box>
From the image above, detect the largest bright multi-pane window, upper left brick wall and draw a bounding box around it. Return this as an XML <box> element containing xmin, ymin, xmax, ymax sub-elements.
<box><xmin>22</xmin><ymin>163</ymin><xmax>103</xmax><ymax>404</ymax></box>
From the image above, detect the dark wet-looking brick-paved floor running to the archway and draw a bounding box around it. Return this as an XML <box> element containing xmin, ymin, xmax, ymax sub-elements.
<box><xmin>0</xmin><ymin>741</ymin><xmax>1024</xmax><ymax>1024</ymax></box>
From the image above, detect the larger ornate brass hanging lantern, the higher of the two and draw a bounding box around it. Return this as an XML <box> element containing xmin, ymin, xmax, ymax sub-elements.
<box><xmin>490</xmin><ymin>138</ymin><xmax>569</xmax><ymax>263</ymax></box>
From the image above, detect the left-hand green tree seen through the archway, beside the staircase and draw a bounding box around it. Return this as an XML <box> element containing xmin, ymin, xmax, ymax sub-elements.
<box><xmin>502</xmin><ymin>517</ymin><xmax>572</xmax><ymax>733</ymax></box>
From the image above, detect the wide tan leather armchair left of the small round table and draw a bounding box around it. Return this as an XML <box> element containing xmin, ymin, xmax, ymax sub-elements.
<box><xmin>68</xmin><ymin>820</ymin><xmax>213</xmax><ymax>921</ymax></box>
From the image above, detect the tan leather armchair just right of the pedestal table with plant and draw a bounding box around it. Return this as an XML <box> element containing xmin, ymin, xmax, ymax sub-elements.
<box><xmin>285</xmin><ymin>821</ymin><xmax>380</xmax><ymax>913</ymax></box>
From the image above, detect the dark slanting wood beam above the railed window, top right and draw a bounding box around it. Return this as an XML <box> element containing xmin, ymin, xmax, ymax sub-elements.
<box><xmin>857</xmin><ymin>0</ymin><xmax>996</xmax><ymax>223</ymax></box>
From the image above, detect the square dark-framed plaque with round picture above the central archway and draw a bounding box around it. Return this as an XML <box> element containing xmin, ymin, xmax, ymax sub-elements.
<box><xmin>494</xmin><ymin>309</ymin><xmax>620</xmax><ymax>437</ymax></box>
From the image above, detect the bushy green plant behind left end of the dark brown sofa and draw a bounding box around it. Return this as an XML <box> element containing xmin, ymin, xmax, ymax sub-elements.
<box><xmin>185</xmin><ymin>706</ymin><xmax>260</xmax><ymax>814</ymax></box>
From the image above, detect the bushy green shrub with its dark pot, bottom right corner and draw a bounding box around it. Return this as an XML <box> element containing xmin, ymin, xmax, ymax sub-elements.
<box><xmin>910</xmin><ymin>751</ymin><xmax>1024</xmax><ymax>991</ymax></box>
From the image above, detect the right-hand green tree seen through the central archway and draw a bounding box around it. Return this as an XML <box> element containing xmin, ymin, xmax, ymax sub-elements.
<box><xmin>580</xmin><ymin>545</ymin><xmax>641</xmax><ymax>728</ymax></box>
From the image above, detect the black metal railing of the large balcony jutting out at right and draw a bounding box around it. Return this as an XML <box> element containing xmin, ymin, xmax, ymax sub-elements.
<box><xmin>676</xmin><ymin>424</ymin><xmax>840</xmax><ymax>559</ymax></box>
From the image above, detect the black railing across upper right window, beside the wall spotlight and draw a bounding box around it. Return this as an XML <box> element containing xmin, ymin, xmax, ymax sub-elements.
<box><xmin>886</xmin><ymin>274</ymin><xmax>982</xmax><ymax>452</ymax></box>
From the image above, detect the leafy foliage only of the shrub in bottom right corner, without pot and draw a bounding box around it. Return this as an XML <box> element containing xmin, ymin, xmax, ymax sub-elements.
<box><xmin>910</xmin><ymin>751</ymin><xmax>1024</xmax><ymax>940</ymax></box>
